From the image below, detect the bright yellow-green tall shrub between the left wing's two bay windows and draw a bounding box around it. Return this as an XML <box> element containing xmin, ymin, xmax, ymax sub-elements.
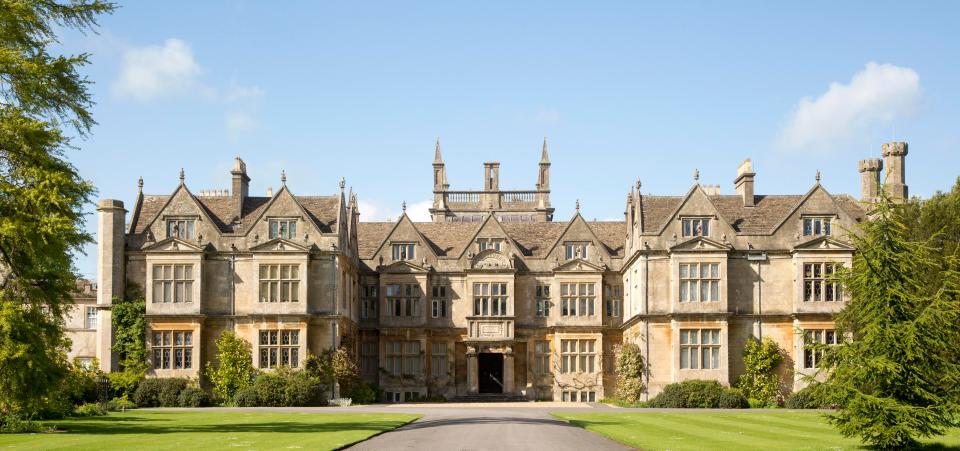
<box><xmin>205</xmin><ymin>330</ymin><xmax>257</xmax><ymax>402</ymax></box>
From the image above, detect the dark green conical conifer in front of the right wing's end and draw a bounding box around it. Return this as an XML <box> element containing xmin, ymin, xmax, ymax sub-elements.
<box><xmin>814</xmin><ymin>193</ymin><xmax>960</xmax><ymax>448</ymax></box>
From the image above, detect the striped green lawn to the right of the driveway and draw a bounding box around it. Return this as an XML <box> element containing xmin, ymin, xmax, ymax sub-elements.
<box><xmin>553</xmin><ymin>411</ymin><xmax>960</xmax><ymax>451</ymax></box>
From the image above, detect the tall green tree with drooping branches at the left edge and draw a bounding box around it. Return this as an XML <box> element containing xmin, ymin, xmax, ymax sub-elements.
<box><xmin>0</xmin><ymin>0</ymin><xmax>114</xmax><ymax>414</ymax></box>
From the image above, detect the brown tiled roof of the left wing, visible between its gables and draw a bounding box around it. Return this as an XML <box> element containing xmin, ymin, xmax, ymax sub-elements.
<box><xmin>130</xmin><ymin>195</ymin><xmax>340</xmax><ymax>233</ymax></box>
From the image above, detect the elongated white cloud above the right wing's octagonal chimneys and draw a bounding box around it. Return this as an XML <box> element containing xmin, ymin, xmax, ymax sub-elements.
<box><xmin>780</xmin><ymin>62</ymin><xmax>920</xmax><ymax>149</ymax></box>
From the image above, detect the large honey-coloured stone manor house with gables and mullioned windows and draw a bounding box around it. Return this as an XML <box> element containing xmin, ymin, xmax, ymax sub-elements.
<box><xmin>80</xmin><ymin>142</ymin><xmax>907</xmax><ymax>402</ymax></box>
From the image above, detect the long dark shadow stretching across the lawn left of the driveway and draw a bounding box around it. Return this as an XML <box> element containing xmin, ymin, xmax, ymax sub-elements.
<box><xmin>48</xmin><ymin>416</ymin><xmax>403</xmax><ymax>435</ymax></box>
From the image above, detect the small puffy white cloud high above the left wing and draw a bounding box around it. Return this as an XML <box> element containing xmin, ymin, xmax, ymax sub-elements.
<box><xmin>112</xmin><ymin>38</ymin><xmax>203</xmax><ymax>101</ymax></box>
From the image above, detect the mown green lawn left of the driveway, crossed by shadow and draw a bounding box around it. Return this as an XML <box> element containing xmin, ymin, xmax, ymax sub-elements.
<box><xmin>0</xmin><ymin>410</ymin><xmax>419</xmax><ymax>451</ymax></box>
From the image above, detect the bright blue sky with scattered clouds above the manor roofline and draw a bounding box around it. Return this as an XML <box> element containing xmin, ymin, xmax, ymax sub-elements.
<box><xmin>63</xmin><ymin>1</ymin><xmax>960</xmax><ymax>277</ymax></box>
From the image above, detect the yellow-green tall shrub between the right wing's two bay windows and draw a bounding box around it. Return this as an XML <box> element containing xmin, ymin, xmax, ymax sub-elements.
<box><xmin>737</xmin><ymin>337</ymin><xmax>784</xmax><ymax>407</ymax></box>
